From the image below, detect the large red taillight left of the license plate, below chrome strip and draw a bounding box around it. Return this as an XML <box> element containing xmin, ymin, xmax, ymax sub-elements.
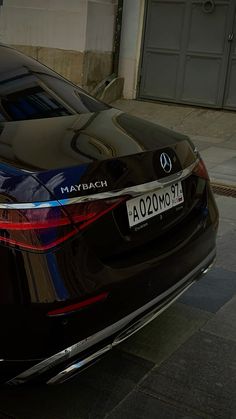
<box><xmin>0</xmin><ymin>197</ymin><xmax>125</xmax><ymax>251</ymax></box>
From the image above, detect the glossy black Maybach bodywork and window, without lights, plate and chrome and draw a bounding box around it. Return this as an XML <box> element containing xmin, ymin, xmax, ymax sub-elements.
<box><xmin>0</xmin><ymin>46</ymin><xmax>218</xmax><ymax>384</ymax></box>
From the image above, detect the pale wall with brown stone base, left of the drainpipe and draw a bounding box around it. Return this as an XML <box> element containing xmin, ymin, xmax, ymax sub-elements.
<box><xmin>0</xmin><ymin>0</ymin><xmax>117</xmax><ymax>90</ymax></box>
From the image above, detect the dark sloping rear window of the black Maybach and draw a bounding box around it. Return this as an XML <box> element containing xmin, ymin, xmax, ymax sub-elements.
<box><xmin>0</xmin><ymin>46</ymin><xmax>109</xmax><ymax>122</ymax></box>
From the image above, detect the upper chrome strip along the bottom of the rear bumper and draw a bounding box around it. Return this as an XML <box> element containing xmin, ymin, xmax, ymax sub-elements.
<box><xmin>8</xmin><ymin>249</ymin><xmax>216</xmax><ymax>384</ymax></box>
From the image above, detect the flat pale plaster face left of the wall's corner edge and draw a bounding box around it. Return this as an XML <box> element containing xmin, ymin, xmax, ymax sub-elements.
<box><xmin>0</xmin><ymin>0</ymin><xmax>87</xmax><ymax>51</ymax></box>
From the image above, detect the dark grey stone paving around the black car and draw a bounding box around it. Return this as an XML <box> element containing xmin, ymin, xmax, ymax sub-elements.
<box><xmin>0</xmin><ymin>103</ymin><xmax>236</xmax><ymax>419</ymax></box>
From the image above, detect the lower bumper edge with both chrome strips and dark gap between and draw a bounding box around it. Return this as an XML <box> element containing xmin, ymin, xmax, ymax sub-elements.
<box><xmin>5</xmin><ymin>248</ymin><xmax>216</xmax><ymax>385</ymax></box>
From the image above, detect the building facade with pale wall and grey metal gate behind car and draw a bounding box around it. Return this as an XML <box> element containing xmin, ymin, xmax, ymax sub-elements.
<box><xmin>0</xmin><ymin>0</ymin><xmax>236</xmax><ymax>109</ymax></box>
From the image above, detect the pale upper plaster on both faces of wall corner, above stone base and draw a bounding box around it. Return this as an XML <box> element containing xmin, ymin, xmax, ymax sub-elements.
<box><xmin>0</xmin><ymin>0</ymin><xmax>117</xmax><ymax>52</ymax></box>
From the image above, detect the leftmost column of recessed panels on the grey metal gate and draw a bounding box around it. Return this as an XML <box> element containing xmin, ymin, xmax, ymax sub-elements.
<box><xmin>140</xmin><ymin>0</ymin><xmax>185</xmax><ymax>101</ymax></box>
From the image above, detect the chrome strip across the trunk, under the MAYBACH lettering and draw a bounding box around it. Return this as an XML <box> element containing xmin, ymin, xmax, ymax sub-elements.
<box><xmin>0</xmin><ymin>159</ymin><xmax>199</xmax><ymax>209</ymax></box>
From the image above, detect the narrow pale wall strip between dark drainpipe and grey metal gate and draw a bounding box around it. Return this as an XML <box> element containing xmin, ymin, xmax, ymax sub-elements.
<box><xmin>119</xmin><ymin>0</ymin><xmax>145</xmax><ymax>99</ymax></box>
